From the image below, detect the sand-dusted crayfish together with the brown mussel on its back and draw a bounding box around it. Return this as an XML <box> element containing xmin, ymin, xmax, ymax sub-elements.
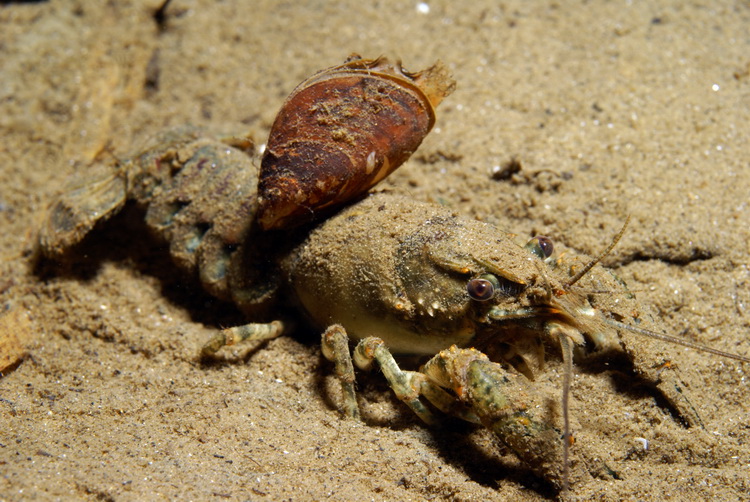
<box><xmin>39</xmin><ymin>57</ymin><xmax>750</xmax><ymax>490</ymax></box>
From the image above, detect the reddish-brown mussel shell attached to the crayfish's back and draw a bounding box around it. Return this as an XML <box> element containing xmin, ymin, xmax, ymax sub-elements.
<box><xmin>258</xmin><ymin>55</ymin><xmax>455</xmax><ymax>230</ymax></box>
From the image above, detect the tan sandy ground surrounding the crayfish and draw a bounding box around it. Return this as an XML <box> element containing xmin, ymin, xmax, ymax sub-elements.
<box><xmin>0</xmin><ymin>0</ymin><xmax>750</xmax><ymax>501</ymax></box>
